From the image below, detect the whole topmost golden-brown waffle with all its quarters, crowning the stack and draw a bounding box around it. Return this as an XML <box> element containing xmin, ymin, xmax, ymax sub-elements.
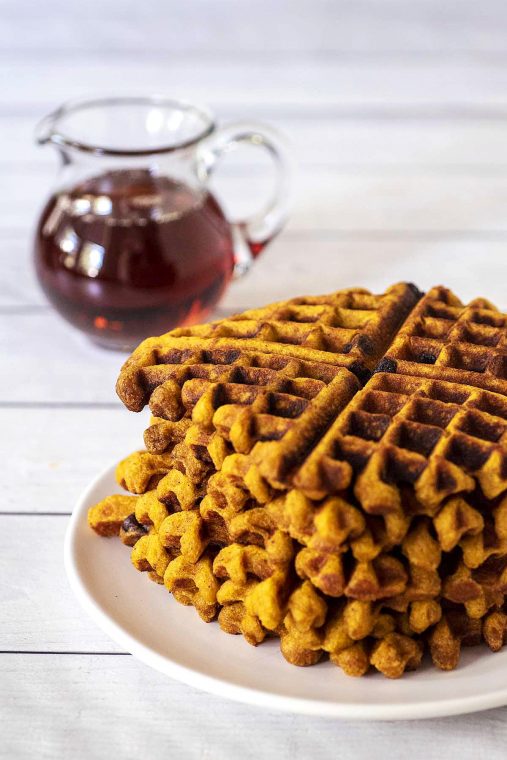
<box><xmin>115</xmin><ymin>284</ymin><xmax>507</xmax><ymax>513</ymax></box>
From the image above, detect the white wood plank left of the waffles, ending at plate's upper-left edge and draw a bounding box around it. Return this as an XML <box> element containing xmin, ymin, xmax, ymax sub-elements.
<box><xmin>0</xmin><ymin>406</ymin><xmax>143</xmax><ymax>512</ymax></box>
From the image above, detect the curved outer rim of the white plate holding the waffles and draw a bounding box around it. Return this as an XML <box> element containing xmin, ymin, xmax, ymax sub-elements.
<box><xmin>63</xmin><ymin>463</ymin><xmax>507</xmax><ymax>721</ymax></box>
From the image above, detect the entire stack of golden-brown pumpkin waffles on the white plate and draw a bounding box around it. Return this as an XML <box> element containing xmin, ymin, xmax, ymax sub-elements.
<box><xmin>89</xmin><ymin>284</ymin><xmax>507</xmax><ymax>678</ymax></box>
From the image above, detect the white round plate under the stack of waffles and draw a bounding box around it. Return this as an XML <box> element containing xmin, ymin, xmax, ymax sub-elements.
<box><xmin>65</xmin><ymin>467</ymin><xmax>507</xmax><ymax>720</ymax></box>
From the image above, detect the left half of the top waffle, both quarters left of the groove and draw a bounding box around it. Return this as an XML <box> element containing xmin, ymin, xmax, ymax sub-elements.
<box><xmin>118</xmin><ymin>285</ymin><xmax>419</xmax><ymax>498</ymax></box>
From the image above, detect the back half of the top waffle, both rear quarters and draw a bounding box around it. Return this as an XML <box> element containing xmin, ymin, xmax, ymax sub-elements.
<box><xmin>117</xmin><ymin>283</ymin><xmax>507</xmax><ymax>411</ymax></box>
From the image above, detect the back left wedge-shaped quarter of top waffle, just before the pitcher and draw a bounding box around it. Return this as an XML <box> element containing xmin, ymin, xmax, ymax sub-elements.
<box><xmin>116</xmin><ymin>283</ymin><xmax>420</xmax><ymax>411</ymax></box>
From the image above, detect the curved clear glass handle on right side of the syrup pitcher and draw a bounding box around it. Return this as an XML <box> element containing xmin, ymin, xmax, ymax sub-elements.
<box><xmin>196</xmin><ymin>122</ymin><xmax>294</xmax><ymax>277</ymax></box>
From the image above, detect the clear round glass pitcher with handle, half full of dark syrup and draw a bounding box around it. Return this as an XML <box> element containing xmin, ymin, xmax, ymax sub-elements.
<box><xmin>35</xmin><ymin>97</ymin><xmax>291</xmax><ymax>349</ymax></box>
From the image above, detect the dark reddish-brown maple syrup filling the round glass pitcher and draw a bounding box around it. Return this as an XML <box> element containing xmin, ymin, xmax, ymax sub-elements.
<box><xmin>35</xmin><ymin>169</ymin><xmax>234</xmax><ymax>349</ymax></box>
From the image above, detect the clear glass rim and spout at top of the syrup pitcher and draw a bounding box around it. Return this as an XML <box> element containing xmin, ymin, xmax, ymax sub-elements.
<box><xmin>35</xmin><ymin>95</ymin><xmax>216</xmax><ymax>157</ymax></box>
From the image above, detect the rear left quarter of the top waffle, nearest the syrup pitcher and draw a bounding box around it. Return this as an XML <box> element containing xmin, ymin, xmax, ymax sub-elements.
<box><xmin>117</xmin><ymin>283</ymin><xmax>420</xmax><ymax>420</ymax></box>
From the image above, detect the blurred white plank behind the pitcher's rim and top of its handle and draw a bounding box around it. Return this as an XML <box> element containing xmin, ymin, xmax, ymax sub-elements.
<box><xmin>8</xmin><ymin>115</ymin><xmax>507</xmax><ymax>170</ymax></box>
